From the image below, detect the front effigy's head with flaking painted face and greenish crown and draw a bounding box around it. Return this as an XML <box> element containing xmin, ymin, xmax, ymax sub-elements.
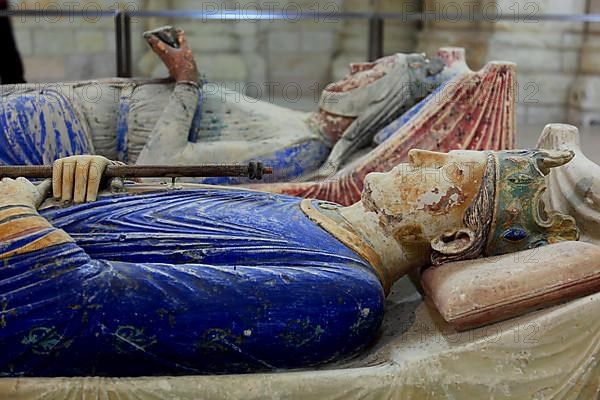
<box><xmin>362</xmin><ymin>150</ymin><xmax>578</xmax><ymax>263</ymax></box>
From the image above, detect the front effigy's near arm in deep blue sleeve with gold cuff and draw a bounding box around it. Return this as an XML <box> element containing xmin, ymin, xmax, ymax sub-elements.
<box><xmin>0</xmin><ymin>205</ymin><xmax>383</xmax><ymax>376</ymax></box>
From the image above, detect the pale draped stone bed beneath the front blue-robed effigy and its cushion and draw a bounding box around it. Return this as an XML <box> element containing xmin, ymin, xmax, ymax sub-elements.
<box><xmin>5</xmin><ymin>270</ymin><xmax>600</xmax><ymax>400</ymax></box>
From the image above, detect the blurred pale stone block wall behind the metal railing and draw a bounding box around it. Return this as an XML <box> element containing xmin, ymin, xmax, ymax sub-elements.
<box><xmin>11</xmin><ymin>0</ymin><xmax>600</xmax><ymax>125</ymax></box>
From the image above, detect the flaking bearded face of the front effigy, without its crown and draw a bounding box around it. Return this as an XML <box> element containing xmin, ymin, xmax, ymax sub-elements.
<box><xmin>362</xmin><ymin>150</ymin><xmax>486</xmax><ymax>253</ymax></box>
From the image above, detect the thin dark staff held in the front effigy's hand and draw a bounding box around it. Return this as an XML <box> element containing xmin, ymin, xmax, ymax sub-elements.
<box><xmin>0</xmin><ymin>162</ymin><xmax>273</xmax><ymax>179</ymax></box>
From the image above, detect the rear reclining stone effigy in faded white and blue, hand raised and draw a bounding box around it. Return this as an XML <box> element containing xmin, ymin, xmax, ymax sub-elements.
<box><xmin>0</xmin><ymin>27</ymin><xmax>467</xmax><ymax>183</ymax></box>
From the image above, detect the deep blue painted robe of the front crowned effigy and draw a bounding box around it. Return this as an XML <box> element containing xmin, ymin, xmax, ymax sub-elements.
<box><xmin>0</xmin><ymin>189</ymin><xmax>384</xmax><ymax>376</ymax></box>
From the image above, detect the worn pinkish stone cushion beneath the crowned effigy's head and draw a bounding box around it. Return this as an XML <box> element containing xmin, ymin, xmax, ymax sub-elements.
<box><xmin>421</xmin><ymin>242</ymin><xmax>600</xmax><ymax>331</ymax></box>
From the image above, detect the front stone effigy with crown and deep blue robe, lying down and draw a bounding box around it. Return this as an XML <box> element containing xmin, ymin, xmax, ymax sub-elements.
<box><xmin>0</xmin><ymin>145</ymin><xmax>577</xmax><ymax>376</ymax></box>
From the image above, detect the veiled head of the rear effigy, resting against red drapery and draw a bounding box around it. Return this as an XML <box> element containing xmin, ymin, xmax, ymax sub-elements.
<box><xmin>286</xmin><ymin>47</ymin><xmax>470</xmax><ymax>180</ymax></box>
